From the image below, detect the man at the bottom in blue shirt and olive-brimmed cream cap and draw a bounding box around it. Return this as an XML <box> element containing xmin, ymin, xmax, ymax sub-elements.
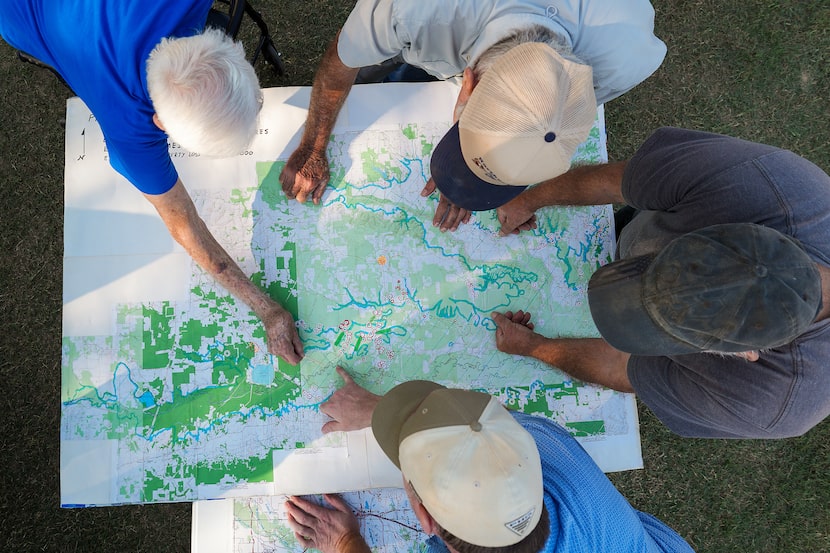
<box><xmin>286</xmin><ymin>367</ymin><xmax>692</xmax><ymax>553</ymax></box>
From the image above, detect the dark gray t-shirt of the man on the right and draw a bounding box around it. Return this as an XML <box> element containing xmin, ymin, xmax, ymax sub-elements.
<box><xmin>619</xmin><ymin>128</ymin><xmax>830</xmax><ymax>438</ymax></box>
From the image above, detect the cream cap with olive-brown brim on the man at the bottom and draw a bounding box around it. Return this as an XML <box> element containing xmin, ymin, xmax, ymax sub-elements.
<box><xmin>372</xmin><ymin>381</ymin><xmax>543</xmax><ymax>547</ymax></box>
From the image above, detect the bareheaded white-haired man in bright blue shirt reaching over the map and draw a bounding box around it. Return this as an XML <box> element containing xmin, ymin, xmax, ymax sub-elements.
<box><xmin>0</xmin><ymin>0</ymin><xmax>303</xmax><ymax>364</ymax></box>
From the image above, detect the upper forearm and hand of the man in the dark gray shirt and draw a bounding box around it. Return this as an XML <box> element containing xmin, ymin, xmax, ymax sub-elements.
<box><xmin>496</xmin><ymin>161</ymin><xmax>628</xmax><ymax>236</ymax></box>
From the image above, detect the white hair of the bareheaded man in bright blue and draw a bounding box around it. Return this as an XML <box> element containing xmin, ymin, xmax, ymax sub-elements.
<box><xmin>147</xmin><ymin>27</ymin><xmax>262</xmax><ymax>157</ymax></box>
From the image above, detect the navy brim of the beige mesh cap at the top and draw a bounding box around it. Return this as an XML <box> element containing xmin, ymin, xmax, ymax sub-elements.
<box><xmin>430</xmin><ymin>123</ymin><xmax>527</xmax><ymax>211</ymax></box>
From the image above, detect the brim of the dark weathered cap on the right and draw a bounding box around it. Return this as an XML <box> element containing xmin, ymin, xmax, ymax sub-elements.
<box><xmin>588</xmin><ymin>255</ymin><xmax>700</xmax><ymax>356</ymax></box>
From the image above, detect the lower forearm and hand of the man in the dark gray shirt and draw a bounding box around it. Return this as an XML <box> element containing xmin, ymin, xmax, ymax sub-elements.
<box><xmin>492</xmin><ymin>311</ymin><xmax>634</xmax><ymax>392</ymax></box>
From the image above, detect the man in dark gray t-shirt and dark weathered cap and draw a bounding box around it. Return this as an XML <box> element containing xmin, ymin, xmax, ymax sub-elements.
<box><xmin>493</xmin><ymin>128</ymin><xmax>830</xmax><ymax>438</ymax></box>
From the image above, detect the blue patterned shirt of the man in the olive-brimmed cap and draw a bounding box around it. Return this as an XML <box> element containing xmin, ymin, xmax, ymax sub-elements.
<box><xmin>427</xmin><ymin>412</ymin><xmax>693</xmax><ymax>553</ymax></box>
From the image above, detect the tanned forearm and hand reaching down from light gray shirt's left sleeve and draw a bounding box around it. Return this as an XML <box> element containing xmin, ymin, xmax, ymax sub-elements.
<box><xmin>280</xmin><ymin>32</ymin><xmax>360</xmax><ymax>204</ymax></box>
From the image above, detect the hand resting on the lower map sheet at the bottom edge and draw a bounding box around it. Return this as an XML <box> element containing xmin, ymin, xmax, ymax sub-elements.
<box><xmin>285</xmin><ymin>494</ymin><xmax>369</xmax><ymax>553</ymax></box>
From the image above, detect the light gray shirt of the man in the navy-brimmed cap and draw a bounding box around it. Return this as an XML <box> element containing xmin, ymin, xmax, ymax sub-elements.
<box><xmin>337</xmin><ymin>0</ymin><xmax>666</xmax><ymax>104</ymax></box>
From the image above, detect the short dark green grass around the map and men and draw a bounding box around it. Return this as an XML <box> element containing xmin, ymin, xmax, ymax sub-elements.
<box><xmin>0</xmin><ymin>0</ymin><xmax>830</xmax><ymax>553</ymax></box>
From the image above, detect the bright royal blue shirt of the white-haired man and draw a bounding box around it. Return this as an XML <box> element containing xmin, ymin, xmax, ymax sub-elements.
<box><xmin>0</xmin><ymin>0</ymin><xmax>213</xmax><ymax>194</ymax></box>
